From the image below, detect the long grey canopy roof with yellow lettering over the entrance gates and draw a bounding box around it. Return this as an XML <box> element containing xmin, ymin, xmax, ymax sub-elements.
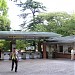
<box><xmin>0</xmin><ymin>31</ymin><xmax>61</xmax><ymax>39</ymax></box>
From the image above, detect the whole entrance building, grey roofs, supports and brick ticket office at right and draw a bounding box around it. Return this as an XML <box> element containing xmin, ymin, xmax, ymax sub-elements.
<box><xmin>0</xmin><ymin>31</ymin><xmax>75</xmax><ymax>59</ymax></box>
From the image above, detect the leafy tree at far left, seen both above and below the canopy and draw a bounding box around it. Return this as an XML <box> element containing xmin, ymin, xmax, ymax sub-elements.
<box><xmin>0</xmin><ymin>0</ymin><xmax>10</xmax><ymax>50</ymax></box>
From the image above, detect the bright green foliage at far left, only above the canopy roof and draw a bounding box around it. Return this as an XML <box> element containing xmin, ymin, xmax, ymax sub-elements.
<box><xmin>0</xmin><ymin>0</ymin><xmax>10</xmax><ymax>31</ymax></box>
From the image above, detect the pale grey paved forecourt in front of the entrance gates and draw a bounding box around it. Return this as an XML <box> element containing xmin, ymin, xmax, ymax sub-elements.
<box><xmin>0</xmin><ymin>59</ymin><xmax>75</xmax><ymax>75</ymax></box>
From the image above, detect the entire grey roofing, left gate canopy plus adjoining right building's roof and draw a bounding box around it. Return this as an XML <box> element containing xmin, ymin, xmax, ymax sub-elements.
<box><xmin>0</xmin><ymin>31</ymin><xmax>75</xmax><ymax>43</ymax></box>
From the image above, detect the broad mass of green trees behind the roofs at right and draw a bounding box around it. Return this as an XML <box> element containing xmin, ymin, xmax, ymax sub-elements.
<box><xmin>34</xmin><ymin>12</ymin><xmax>75</xmax><ymax>36</ymax></box>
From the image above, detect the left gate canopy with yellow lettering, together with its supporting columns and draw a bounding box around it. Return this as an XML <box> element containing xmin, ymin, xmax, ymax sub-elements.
<box><xmin>0</xmin><ymin>31</ymin><xmax>61</xmax><ymax>58</ymax></box>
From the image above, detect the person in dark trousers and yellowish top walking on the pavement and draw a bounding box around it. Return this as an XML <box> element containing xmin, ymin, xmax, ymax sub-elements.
<box><xmin>11</xmin><ymin>48</ymin><xmax>18</xmax><ymax>72</ymax></box>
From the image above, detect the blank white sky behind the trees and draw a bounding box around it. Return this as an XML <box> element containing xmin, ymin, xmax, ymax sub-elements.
<box><xmin>7</xmin><ymin>0</ymin><xmax>75</xmax><ymax>30</ymax></box>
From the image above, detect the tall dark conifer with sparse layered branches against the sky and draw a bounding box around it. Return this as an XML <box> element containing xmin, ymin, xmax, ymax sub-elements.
<box><xmin>17</xmin><ymin>0</ymin><xmax>46</xmax><ymax>30</ymax></box>
